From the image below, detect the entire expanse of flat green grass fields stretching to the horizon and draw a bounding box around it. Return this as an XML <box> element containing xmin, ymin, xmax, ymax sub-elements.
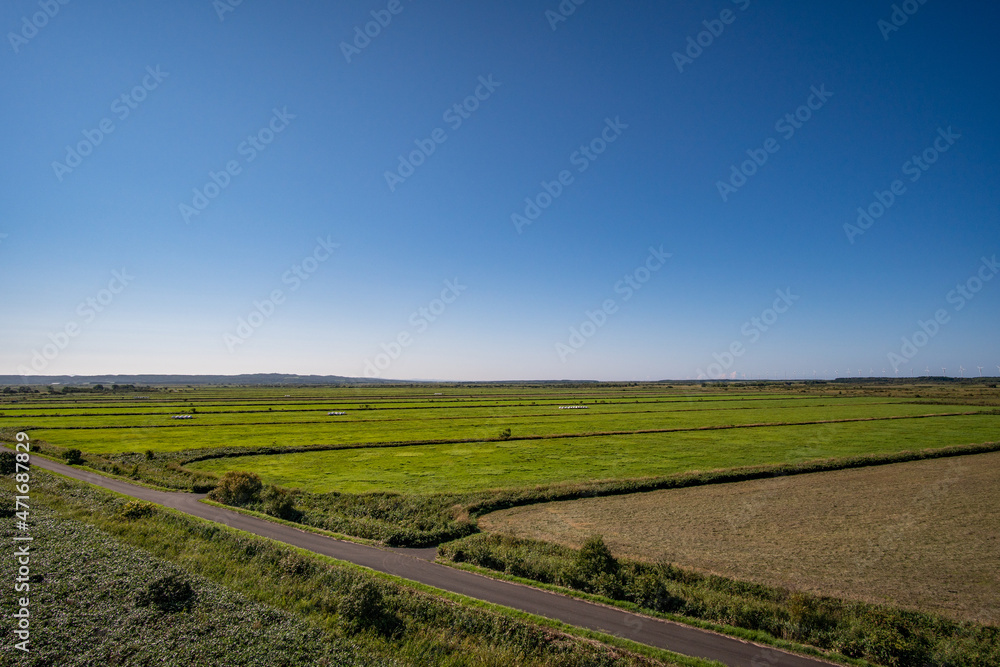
<box><xmin>0</xmin><ymin>383</ymin><xmax>1000</xmax><ymax>494</ymax></box>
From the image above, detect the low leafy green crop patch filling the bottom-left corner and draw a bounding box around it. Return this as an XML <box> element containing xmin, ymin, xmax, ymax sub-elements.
<box><xmin>0</xmin><ymin>498</ymin><xmax>372</xmax><ymax>667</ymax></box>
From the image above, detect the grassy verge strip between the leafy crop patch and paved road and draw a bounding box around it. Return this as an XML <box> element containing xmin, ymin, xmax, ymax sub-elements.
<box><xmin>0</xmin><ymin>469</ymin><xmax>708</xmax><ymax>667</ymax></box>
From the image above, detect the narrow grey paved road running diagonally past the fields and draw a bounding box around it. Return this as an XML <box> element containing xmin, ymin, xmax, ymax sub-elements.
<box><xmin>25</xmin><ymin>457</ymin><xmax>831</xmax><ymax>667</ymax></box>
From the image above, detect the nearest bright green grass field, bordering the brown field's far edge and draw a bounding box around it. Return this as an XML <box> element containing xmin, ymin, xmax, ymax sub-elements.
<box><xmin>190</xmin><ymin>415</ymin><xmax>1000</xmax><ymax>493</ymax></box>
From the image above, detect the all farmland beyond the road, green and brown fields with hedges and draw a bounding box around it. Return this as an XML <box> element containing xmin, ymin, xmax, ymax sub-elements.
<box><xmin>7</xmin><ymin>379</ymin><xmax>1000</xmax><ymax>667</ymax></box>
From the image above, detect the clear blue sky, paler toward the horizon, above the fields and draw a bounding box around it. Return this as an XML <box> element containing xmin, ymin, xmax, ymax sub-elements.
<box><xmin>0</xmin><ymin>0</ymin><xmax>1000</xmax><ymax>380</ymax></box>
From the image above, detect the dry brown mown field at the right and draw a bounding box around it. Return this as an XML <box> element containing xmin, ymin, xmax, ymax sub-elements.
<box><xmin>479</xmin><ymin>452</ymin><xmax>1000</xmax><ymax>625</ymax></box>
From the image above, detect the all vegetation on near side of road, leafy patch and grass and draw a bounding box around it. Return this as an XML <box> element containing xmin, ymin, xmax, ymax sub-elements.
<box><xmin>0</xmin><ymin>469</ymin><xmax>711</xmax><ymax>667</ymax></box>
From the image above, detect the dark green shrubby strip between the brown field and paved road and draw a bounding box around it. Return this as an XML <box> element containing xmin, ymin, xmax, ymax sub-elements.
<box><xmin>438</xmin><ymin>534</ymin><xmax>1000</xmax><ymax>667</ymax></box>
